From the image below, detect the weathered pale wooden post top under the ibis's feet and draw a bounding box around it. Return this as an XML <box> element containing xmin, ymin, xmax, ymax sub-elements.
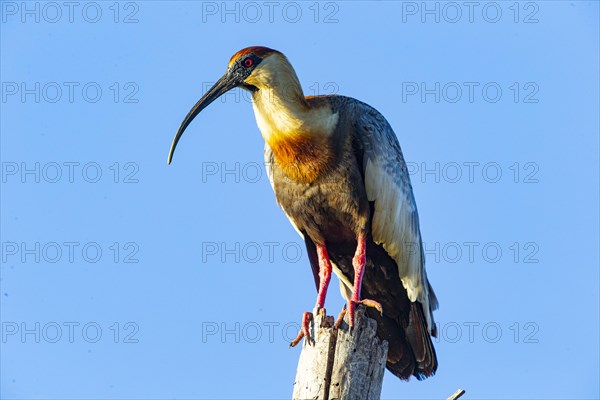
<box><xmin>293</xmin><ymin>305</ymin><xmax>388</xmax><ymax>400</ymax></box>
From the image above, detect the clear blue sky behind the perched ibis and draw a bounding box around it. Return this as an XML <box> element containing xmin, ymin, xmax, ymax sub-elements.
<box><xmin>0</xmin><ymin>1</ymin><xmax>600</xmax><ymax>399</ymax></box>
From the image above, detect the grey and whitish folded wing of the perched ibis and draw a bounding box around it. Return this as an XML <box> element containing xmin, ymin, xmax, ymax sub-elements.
<box><xmin>352</xmin><ymin>99</ymin><xmax>438</xmax><ymax>333</ymax></box>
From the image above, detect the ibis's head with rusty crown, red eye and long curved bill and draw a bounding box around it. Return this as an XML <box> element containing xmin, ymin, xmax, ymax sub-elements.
<box><xmin>168</xmin><ymin>46</ymin><xmax>297</xmax><ymax>164</ymax></box>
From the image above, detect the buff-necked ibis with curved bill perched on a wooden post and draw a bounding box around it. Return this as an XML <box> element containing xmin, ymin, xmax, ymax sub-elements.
<box><xmin>169</xmin><ymin>46</ymin><xmax>438</xmax><ymax>379</ymax></box>
